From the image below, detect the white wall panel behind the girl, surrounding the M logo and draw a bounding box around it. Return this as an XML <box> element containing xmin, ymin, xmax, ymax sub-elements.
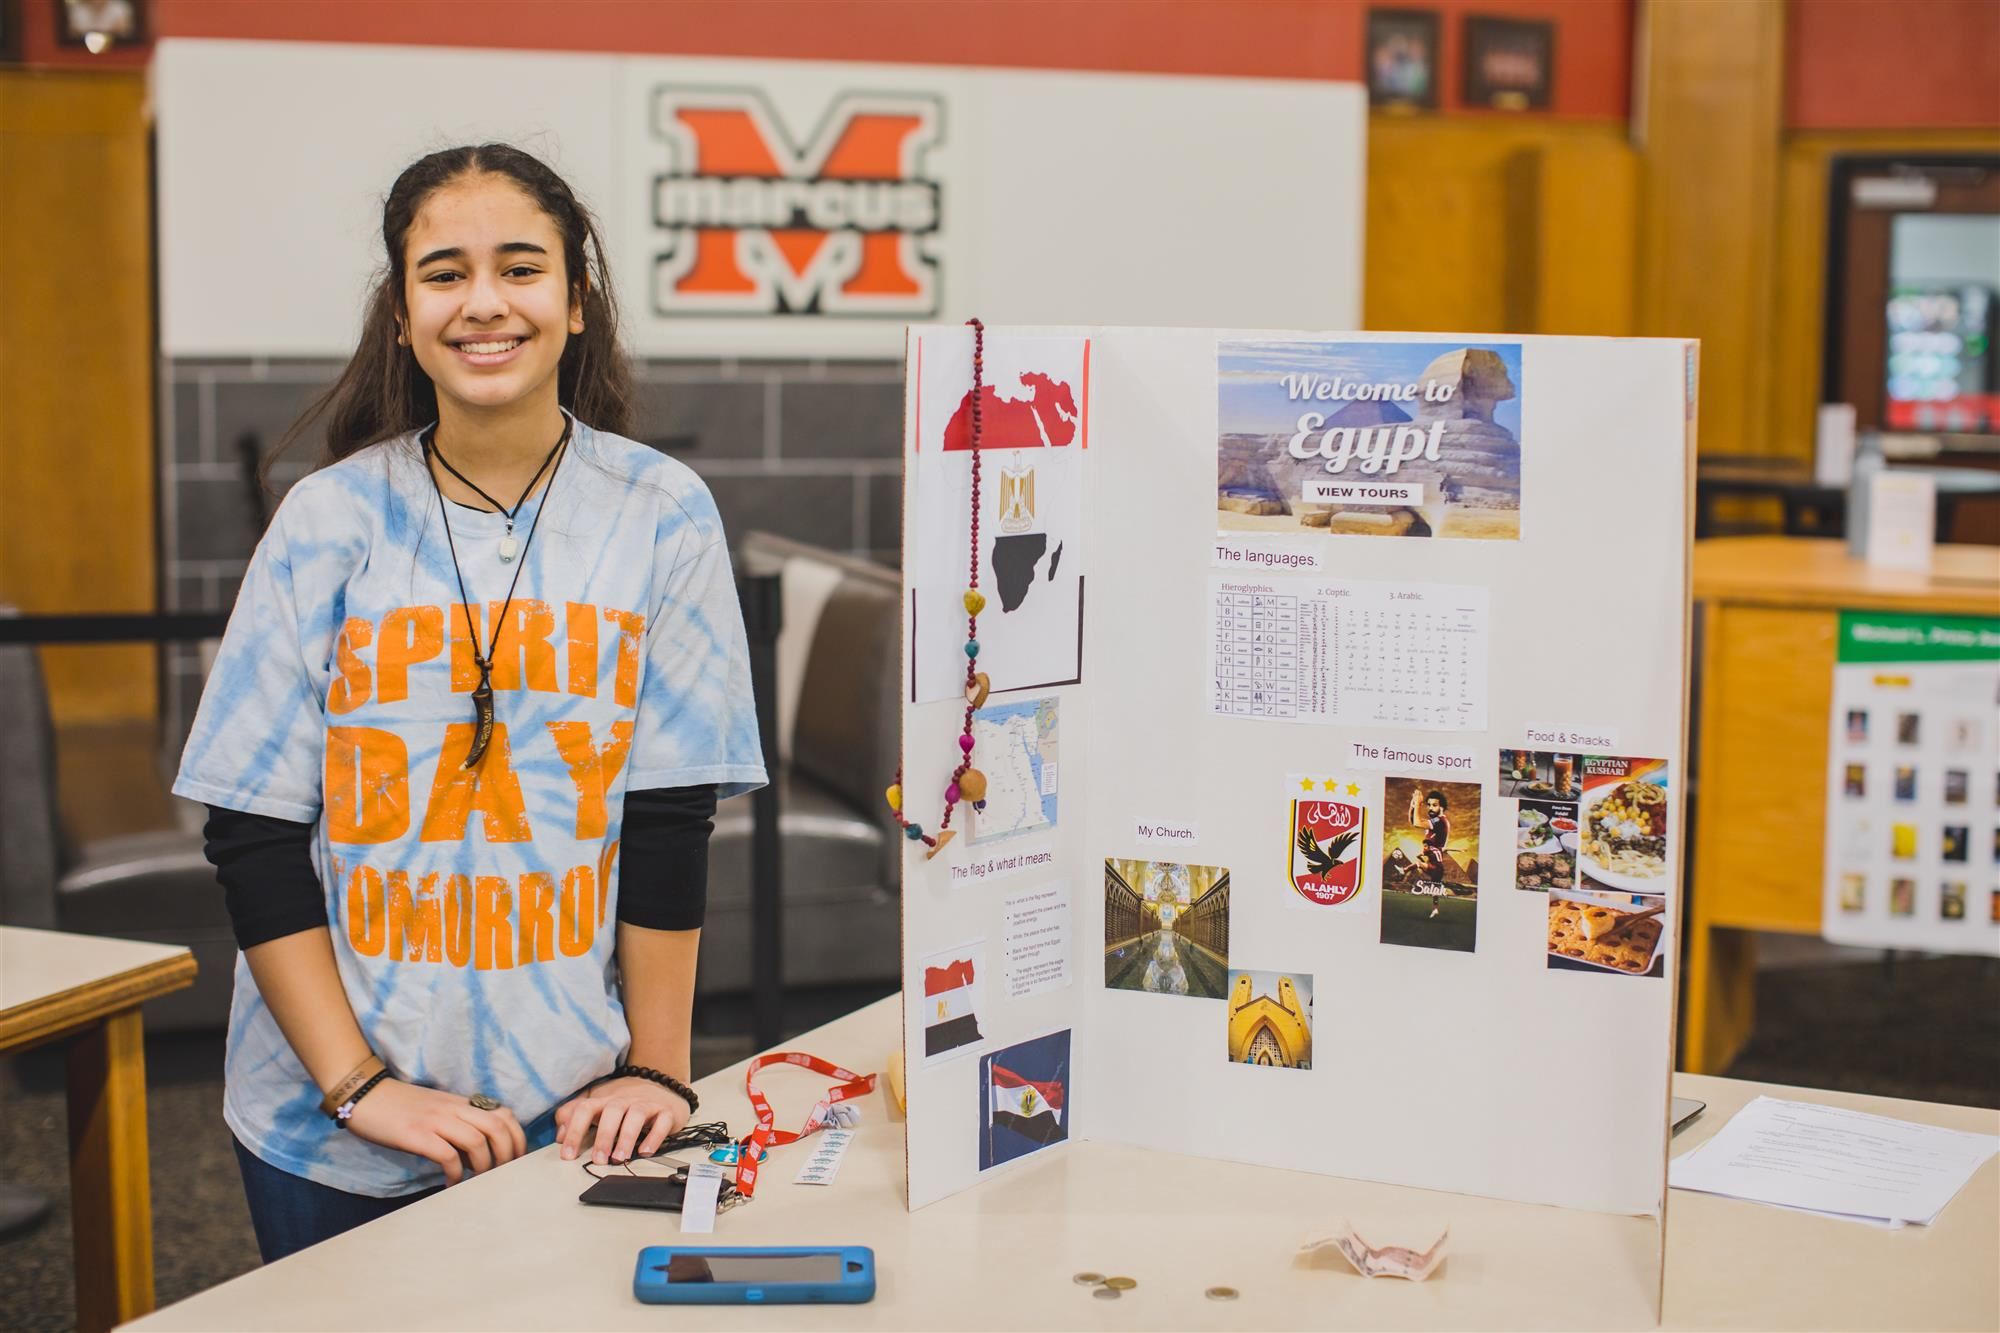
<box><xmin>152</xmin><ymin>40</ymin><xmax>1366</xmax><ymax>358</ymax></box>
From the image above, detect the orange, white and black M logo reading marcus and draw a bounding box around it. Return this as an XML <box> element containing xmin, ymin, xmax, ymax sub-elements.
<box><xmin>652</xmin><ymin>86</ymin><xmax>944</xmax><ymax>316</ymax></box>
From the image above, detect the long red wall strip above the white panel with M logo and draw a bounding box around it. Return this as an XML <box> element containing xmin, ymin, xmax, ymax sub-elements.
<box><xmin>129</xmin><ymin>0</ymin><xmax>1632</xmax><ymax>120</ymax></box>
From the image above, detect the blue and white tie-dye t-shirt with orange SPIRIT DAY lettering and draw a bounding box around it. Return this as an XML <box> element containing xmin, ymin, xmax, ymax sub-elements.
<box><xmin>174</xmin><ymin>422</ymin><xmax>764</xmax><ymax>1197</ymax></box>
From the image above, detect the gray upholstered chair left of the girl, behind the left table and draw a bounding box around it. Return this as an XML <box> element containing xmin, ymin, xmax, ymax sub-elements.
<box><xmin>0</xmin><ymin>644</ymin><xmax>236</xmax><ymax>1031</ymax></box>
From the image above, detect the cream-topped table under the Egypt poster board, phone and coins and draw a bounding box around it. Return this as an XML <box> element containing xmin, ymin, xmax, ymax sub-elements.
<box><xmin>132</xmin><ymin>997</ymin><xmax>2000</xmax><ymax>1331</ymax></box>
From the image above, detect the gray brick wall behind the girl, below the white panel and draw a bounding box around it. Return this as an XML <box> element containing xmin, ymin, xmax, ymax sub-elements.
<box><xmin>160</xmin><ymin>358</ymin><xmax>902</xmax><ymax>737</ymax></box>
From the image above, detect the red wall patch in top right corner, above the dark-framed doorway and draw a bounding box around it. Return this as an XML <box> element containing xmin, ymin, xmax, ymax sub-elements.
<box><xmin>1784</xmin><ymin>0</ymin><xmax>2000</xmax><ymax>130</ymax></box>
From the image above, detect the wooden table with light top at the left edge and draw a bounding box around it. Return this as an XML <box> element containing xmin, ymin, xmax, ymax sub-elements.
<box><xmin>0</xmin><ymin>927</ymin><xmax>194</xmax><ymax>1333</ymax></box>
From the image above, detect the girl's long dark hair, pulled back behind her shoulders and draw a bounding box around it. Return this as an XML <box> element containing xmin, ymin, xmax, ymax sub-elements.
<box><xmin>264</xmin><ymin>144</ymin><xmax>632</xmax><ymax>466</ymax></box>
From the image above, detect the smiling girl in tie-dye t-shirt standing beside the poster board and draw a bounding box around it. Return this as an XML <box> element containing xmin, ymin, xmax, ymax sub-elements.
<box><xmin>174</xmin><ymin>144</ymin><xmax>764</xmax><ymax>1261</ymax></box>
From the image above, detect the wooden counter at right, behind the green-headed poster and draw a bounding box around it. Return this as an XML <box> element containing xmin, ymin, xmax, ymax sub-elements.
<box><xmin>1680</xmin><ymin>536</ymin><xmax>2000</xmax><ymax>1073</ymax></box>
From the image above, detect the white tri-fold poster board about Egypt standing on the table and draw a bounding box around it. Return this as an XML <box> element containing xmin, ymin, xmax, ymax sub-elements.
<box><xmin>902</xmin><ymin>326</ymin><xmax>1696</xmax><ymax>1280</ymax></box>
